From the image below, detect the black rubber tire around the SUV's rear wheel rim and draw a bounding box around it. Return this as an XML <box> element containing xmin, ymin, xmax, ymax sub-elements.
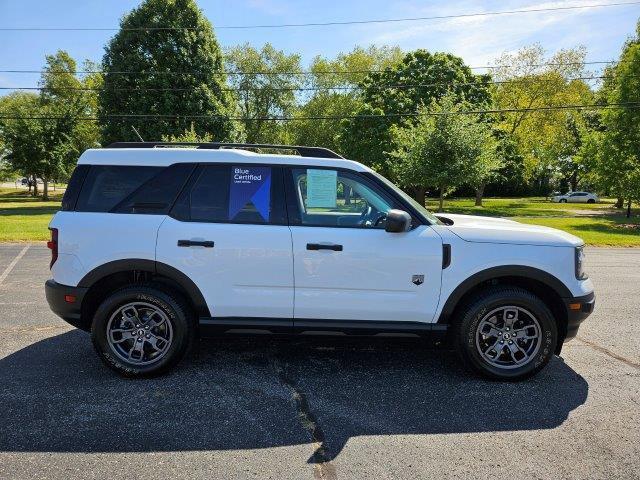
<box><xmin>91</xmin><ymin>284</ymin><xmax>195</xmax><ymax>377</ymax></box>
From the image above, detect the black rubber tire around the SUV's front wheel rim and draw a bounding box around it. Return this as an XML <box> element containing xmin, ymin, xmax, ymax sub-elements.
<box><xmin>454</xmin><ymin>286</ymin><xmax>558</xmax><ymax>381</ymax></box>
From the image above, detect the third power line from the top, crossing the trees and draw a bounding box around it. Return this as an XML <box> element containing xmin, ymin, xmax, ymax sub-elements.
<box><xmin>0</xmin><ymin>75</ymin><xmax>613</xmax><ymax>92</ymax></box>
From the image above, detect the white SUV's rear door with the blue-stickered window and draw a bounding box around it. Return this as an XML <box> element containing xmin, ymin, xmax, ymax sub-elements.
<box><xmin>156</xmin><ymin>164</ymin><xmax>293</xmax><ymax>320</ymax></box>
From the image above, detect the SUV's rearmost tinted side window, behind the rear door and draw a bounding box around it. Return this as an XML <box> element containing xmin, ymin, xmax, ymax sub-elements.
<box><xmin>76</xmin><ymin>165</ymin><xmax>162</xmax><ymax>212</ymax></box>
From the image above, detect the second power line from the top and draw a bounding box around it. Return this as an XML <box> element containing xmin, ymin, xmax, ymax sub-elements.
<box><xmin>0</xmin><ymin>60</ymin><xmax>633</xmax><ymax>76</ymax></box>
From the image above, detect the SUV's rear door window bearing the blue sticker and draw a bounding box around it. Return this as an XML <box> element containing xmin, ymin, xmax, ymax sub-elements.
<box><xmin>172</xmin><ymin>165</ymin><xmax>286</xmax><ymax>224</ymax></box>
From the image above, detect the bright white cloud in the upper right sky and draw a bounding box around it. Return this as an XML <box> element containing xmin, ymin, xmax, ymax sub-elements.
<box><xmin>360</xmin><ymin>0</ymin><xmax>632</xmax><ymax>65</ymax></box>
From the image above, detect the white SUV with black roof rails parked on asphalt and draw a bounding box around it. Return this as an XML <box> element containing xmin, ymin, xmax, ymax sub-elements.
<box><xmin>46</xmin><ymin>142</ymin><xmax>594</xmax><ymax>380</ymax></box>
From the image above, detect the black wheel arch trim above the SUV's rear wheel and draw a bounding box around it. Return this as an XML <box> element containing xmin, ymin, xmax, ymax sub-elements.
<box><xmin>78</xmin><ymin>258</ymin><xmax>210</xmax><ymax>330</ymax></box>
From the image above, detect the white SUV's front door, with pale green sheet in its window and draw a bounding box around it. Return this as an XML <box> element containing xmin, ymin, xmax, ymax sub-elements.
<box><xmin>285</xmin><ymin>167</ymin><xmax>442</xmax><ymax>324</ymax></box>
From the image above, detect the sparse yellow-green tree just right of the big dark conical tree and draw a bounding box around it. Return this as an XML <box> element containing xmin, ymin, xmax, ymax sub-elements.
<box><xmin>225</xmin><ymin>43</ymin><xmax>304</xmax><ymax>143</ymax></box>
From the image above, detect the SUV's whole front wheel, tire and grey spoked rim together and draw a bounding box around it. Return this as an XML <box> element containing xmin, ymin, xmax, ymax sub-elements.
<box><xmin>455</xmin><ymin>287</ymin><xmax>558</xmax><ymax>380</ymax></box>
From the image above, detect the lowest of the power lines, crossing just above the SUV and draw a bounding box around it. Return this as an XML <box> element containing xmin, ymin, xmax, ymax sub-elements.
<box><xmin>0</xmin><ymin>102</ymin><xmax>640</xmax><ymax>122</ymax></box>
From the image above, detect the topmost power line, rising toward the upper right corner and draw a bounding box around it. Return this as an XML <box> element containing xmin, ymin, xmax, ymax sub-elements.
<box><xmin>0</xmin><ymin>1</ymin><xmax>640</xmax><ymax>32</ymax></box>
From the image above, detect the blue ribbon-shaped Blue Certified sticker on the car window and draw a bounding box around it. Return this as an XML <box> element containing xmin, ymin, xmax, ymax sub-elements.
<box><xmin>229</xmin><ymin>165</ymin><xmax>271</xmax><ymax>222</ymax></box>
